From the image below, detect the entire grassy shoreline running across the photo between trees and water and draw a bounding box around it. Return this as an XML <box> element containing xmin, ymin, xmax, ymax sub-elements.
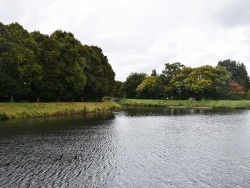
<box><xmin>0</xmin><ymin>99</ymin><xmax>250</xmax><ymax>121</ymax></box>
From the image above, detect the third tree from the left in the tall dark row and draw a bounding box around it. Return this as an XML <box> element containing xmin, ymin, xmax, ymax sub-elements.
<box><xmin>51</xmin><ymin>30</ymin><xmax>86</xmax><ymax>100</ymax></box>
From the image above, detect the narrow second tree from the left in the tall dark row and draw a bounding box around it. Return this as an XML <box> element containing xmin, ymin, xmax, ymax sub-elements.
<box><xmin>32</xmin><ymin>31</ymin><xmax>64</xmax><ymax>101</ymax></box>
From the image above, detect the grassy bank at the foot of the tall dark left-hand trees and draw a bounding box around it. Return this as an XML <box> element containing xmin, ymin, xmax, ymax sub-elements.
<box><xmin>0</xmin><ymin>101</ymin><xmax>120</xmax><ymax>120</ymax></box>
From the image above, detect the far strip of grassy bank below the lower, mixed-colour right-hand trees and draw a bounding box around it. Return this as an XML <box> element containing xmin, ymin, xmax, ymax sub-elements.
<box><xmin>118</xmin><ymin>99</ymin><xmax>250</xmax><ymax>109</ymax></box>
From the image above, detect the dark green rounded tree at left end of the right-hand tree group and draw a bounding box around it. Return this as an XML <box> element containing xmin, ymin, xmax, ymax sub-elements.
<box><xmin>121</xmin><ymin>73</ymin><xmax>147</xmax><ymax>99</ymax></box>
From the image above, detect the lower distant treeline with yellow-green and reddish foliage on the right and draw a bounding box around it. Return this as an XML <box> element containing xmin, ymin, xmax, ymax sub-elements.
<box><xmin>117</xmin><ymin>59</ymin><xmax>250</xmax><ymax>100</ymax></box>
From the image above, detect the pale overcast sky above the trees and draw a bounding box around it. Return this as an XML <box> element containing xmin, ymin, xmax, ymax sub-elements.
<box><xmin>0</xmin><ymin>0</ymin><xmax>250</xmax><ymax>81</ymax></box>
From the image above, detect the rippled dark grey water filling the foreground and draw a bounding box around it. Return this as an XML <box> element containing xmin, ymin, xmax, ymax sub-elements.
<box><xmin>0</xmin><ymin>108</ymin><xmax>250</xmax><ymax>188</ymax></box>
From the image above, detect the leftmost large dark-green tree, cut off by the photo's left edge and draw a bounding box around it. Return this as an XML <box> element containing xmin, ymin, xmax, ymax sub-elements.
<box><xmin>0</xmin><ymin>23</ymin><xmax>42</xmax><ymax>101</ymax></box>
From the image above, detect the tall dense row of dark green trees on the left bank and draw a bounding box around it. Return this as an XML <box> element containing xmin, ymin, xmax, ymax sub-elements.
<box><xmin>0</xmin><ymin>23</ymin><xmax>115</xmax><ymax>102</ymax></box>
